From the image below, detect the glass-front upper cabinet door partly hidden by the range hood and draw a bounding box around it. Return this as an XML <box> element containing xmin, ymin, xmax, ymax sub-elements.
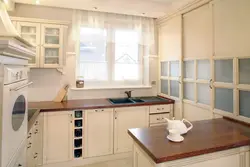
<box><xmin>16</xmin><ymin>22</ymin><xmax>41</xmax><ymax>67</ymax></box>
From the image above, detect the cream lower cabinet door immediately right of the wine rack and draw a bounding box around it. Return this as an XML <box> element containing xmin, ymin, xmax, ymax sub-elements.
<box><xmin>84</xmin><ymin>109</ymin><xmax>114</xmax><ymax>157</ymax></box>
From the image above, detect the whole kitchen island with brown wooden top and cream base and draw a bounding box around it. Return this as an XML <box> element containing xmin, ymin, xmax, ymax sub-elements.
<box><xmin>128</xmin><ymin>119</ymin><xmax>250</xmax><ymax>167</ymax></box>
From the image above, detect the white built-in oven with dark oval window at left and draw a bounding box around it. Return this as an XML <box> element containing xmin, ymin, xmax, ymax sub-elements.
<box><xmin>0</xmin><ymin>65</ymin><xmax>32</xmax><ymax>167</ymax></box>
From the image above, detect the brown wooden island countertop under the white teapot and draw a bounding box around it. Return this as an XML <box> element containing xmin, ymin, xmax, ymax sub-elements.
<box><xmin>128</xmin><ymin>118</ymin><xmax>250</xmax><ymax>163</ymax></box>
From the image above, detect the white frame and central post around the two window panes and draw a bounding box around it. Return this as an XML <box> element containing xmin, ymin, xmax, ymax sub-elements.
<box><xmin>75</xmin><ymin>24</ymin><xmax>145</xmax><ymax>89</ymax></box>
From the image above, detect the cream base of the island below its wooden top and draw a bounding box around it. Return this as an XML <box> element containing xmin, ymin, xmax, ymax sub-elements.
<box><xmin>133</xmin><ymin>143</ymin><xmax>249</xmax><ymax>167</ymax></box>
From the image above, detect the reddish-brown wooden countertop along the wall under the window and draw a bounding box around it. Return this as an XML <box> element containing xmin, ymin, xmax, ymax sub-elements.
<box><xmin>28</xmin><ymin>98</ymin><xmax>174</xmax><ymax>112</ymax></box>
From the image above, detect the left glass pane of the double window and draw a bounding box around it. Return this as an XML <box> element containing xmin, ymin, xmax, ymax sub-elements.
<box><xmin>78</xmin><ymin>28</ymin><xmax>108</xmax><ymax>81</ymax></box>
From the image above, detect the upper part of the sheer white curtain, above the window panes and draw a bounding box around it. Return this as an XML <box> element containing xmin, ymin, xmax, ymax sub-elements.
<box><xmin>72</xmin><ymin>10</ymin><xmax>155</xmax><ymax>48</ymax></box>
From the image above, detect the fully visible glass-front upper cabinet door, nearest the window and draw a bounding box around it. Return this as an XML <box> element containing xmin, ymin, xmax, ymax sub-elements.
<box><xmin>41</xmin><ymin>24</ymin><xmax>63</xmax><ymax>68</ymax></box>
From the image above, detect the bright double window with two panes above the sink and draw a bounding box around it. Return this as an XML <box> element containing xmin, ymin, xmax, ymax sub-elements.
<box><xmin>78</xmin><ymin>27</ymin><xmax>143</xmax><ymax>87</ymax></box>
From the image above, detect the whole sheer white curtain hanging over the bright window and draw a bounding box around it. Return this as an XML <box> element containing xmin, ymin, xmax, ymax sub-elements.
<box><xmin>72</xmin><ymin>10</ymin><xmax>155</xmax><ymax>87</ymax></box>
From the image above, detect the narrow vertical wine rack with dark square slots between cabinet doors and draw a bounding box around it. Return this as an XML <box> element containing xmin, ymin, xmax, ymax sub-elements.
<box><xmin>73</xmin><ymin>110</ymin><xmax>84</xmax><ymax>159</ymax></box>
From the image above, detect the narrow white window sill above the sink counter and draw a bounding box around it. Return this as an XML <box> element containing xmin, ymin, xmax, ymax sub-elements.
<box><xmin>70</xmin><ymin>85</ymin><xmax>152</xmax><ymax>91</ymax></box>
